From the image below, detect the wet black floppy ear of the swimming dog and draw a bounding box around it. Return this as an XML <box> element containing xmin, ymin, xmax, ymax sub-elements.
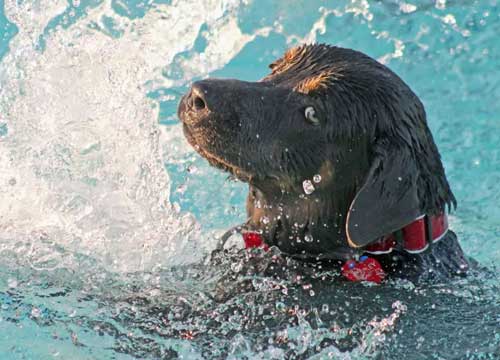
<box><xmin>346</xmin><ymin>141</ymin><xmax>421</xmax><ymax>248</ymax></box>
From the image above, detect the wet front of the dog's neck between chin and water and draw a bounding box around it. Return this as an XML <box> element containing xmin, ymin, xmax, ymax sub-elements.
<box><xmin>246</xmin><ymin>183</ymin><xmax>354</xmax><ymax>258</ymax></box>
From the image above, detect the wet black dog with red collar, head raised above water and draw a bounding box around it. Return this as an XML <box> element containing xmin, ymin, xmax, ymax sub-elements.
<box><xmin>178</xmin><ymin>45</ymin><xmax>468</xmax><ymax>282</ymax></box>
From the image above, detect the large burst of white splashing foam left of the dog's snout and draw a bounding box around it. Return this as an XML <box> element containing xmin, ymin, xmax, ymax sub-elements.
<box><xmin>0</xmin><ymin>0</ymin><xmax>266</xmax><ymax>271</ymax></box>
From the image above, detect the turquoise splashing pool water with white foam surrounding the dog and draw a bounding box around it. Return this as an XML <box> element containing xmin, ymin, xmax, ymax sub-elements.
<box><xmin>0</xmin><ymin>0</ymin><xmax>500</xmax><ymax>360</ymax></box>
